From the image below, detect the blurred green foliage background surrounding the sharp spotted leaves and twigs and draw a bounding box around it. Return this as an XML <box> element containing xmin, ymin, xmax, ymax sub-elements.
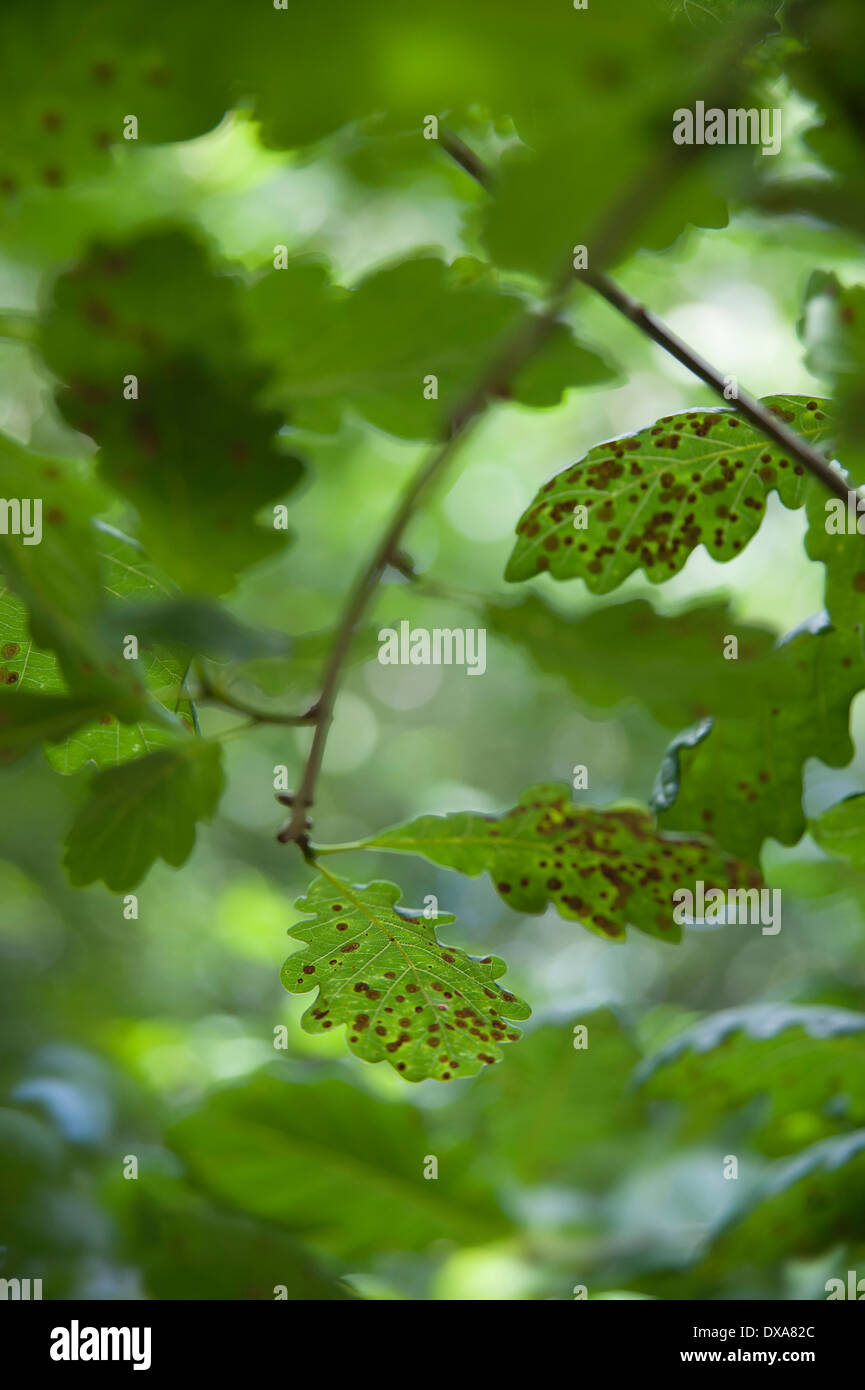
<box><xmin>0</xmin><ymin>0</ymin><xmax>865</xmax><ymax>1300</ymax></box>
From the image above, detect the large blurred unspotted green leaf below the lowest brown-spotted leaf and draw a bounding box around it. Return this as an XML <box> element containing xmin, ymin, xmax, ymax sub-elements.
<box><xmin>168</xmin><ymin>1073</ymin><xmax>509</xmax><ymax>1258</ymax></box>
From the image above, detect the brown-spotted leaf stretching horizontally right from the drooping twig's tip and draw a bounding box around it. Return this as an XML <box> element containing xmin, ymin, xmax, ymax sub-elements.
<box><xmin>353</xmin><ymin>783</ymin><xmax>759</xmax><ymax>941</ymax></box>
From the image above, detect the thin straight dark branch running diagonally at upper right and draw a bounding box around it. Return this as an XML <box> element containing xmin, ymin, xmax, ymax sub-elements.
<box><xmin>439</xmin><ymin>131</ymin><xmax>850</xmax><ymax>502</ymax></box>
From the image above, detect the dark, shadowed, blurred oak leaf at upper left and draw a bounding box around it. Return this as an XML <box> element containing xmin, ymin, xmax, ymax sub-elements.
<box><xmin>40</xmin><ymin>231</ymin><xmax>303</xmax><ymax>594</ymax></box>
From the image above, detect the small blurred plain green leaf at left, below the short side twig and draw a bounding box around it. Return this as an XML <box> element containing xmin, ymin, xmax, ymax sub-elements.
<box><xmin>64</xmin><ymin>739</ymin><xmax>224</xmax><ymax>892</ymax></box>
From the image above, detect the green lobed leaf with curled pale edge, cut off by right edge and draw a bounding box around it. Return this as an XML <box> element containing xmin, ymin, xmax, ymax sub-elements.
<box><xmin>652</xmin><ymin>628</ymin><xmax>865</xmax><ymax>863</ymax></box>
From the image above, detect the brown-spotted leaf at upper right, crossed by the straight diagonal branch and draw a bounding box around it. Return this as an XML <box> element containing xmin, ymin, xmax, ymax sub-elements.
<box><xmin>505</xmin><ymin>396</ymin><xmax>832</xmax><ymax>594</ymax></box>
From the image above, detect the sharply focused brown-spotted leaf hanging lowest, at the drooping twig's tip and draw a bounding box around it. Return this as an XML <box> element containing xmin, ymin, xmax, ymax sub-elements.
<box><xmin>282</xmin><ymin>867</ymin><xmax>531</xmax><ymax>1081</ymax></box>
